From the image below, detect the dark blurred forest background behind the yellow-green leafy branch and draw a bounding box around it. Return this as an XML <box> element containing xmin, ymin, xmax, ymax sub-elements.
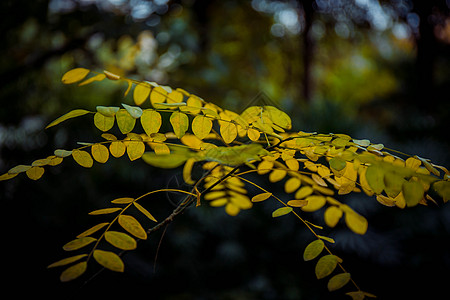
<box><xmin>0</xmin><ymin>0</ymin><xmax>450</xmax><ymax>299</ymax></box>
